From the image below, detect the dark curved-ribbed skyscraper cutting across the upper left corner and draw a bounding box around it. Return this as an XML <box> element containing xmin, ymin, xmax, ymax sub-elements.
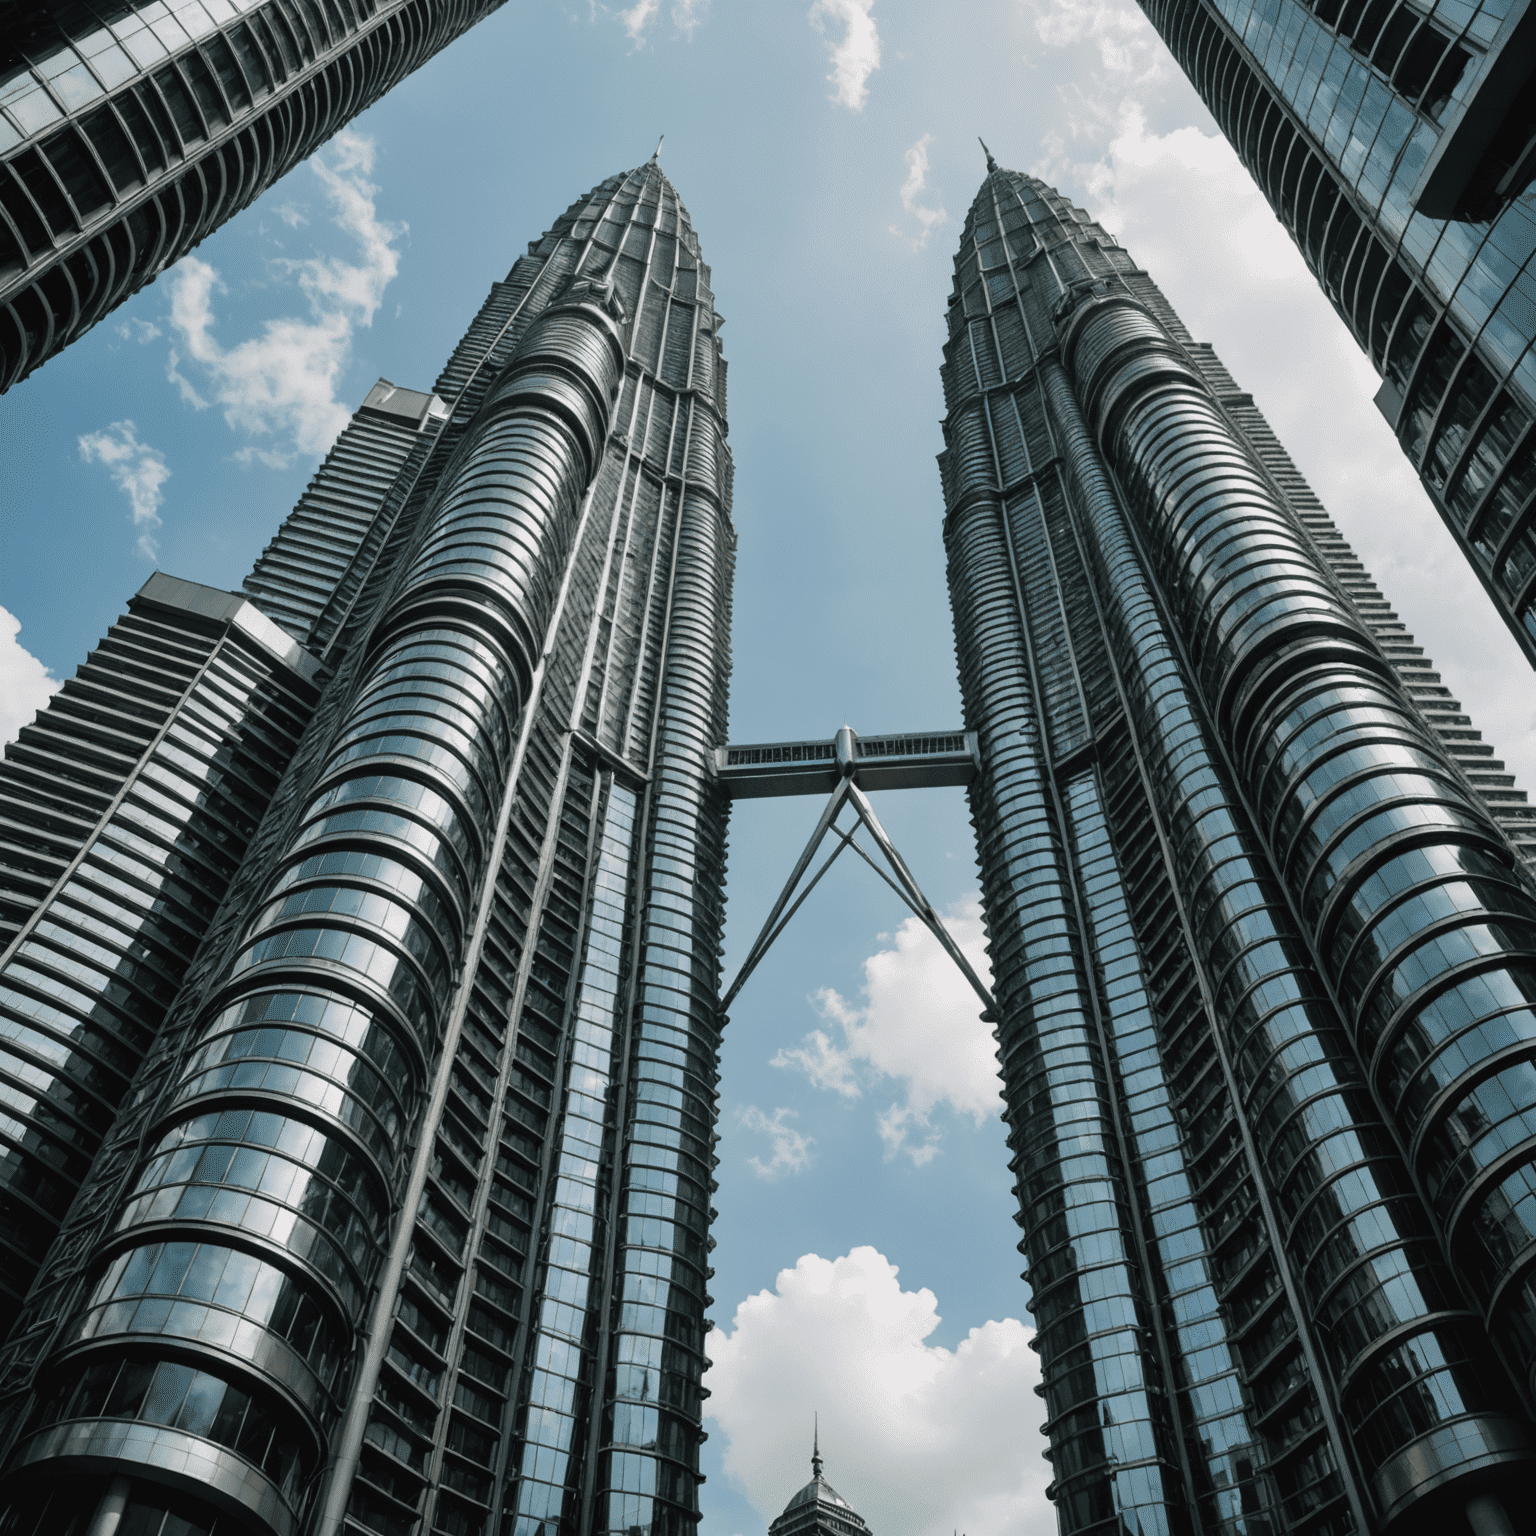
<box><xmin>0</xmin><ymin>0</ymin><xmax>516</xmax><ymax>390</ymax></box>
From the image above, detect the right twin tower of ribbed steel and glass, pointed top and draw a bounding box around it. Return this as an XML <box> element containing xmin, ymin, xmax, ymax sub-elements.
<box><xmin>940</xmin><ymin>160</ymin><xmax>1536</xmax><ymax>1536</ymax></box>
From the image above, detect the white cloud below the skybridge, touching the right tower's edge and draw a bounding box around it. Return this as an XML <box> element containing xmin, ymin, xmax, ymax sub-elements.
<box><xmin>773</xmin><ymin>899</ymin><xmax>998</xmax><ymax>1164</ymax></box>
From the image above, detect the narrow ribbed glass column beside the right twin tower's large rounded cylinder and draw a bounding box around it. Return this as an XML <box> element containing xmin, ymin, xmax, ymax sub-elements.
<box><xmin>1044</xmin><ymin>351</ymin><xmax>1528</xmax><ymax>1519</ymax></box>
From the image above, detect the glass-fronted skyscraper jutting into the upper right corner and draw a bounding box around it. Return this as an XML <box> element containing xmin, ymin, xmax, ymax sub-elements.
<box><xmin>1141</xmin><ymin>0</ymin><xmax>1536</xmax><ymax>664</ymax></box>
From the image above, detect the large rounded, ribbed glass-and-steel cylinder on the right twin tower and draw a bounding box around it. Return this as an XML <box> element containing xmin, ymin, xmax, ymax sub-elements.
<box><xmin>1069</xmin><ymin>285</ymin><xmax>1536</xmax><ymax>1425</ymax></box>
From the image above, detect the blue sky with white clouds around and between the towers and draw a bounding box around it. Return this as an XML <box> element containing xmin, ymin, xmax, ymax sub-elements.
<box><xmin>0</xmin><ymin>0</ymin><xmax>1536</xmax><ymax>1536</ymax></box>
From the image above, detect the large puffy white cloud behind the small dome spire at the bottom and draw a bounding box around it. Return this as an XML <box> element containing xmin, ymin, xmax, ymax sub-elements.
<box><xmin>703</xmin><ymin>1247</ymin><xmax>1057</xmax><ymax>1536</ymax></box>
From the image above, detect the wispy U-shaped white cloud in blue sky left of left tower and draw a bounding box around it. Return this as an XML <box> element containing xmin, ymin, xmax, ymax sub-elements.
<box><xmin>169</xmin><ymin>132</ymin><xmax>406</xmax><ymax>465</ymax></box>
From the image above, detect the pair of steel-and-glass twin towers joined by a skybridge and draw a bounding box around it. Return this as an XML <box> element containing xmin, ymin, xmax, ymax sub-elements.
<box><xmin>0</xmin><ymin>160</ymin><xmax>1536</xmax><ymax>1536</ymax></box>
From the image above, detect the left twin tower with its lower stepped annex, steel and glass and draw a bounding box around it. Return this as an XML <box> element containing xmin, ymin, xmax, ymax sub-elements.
<box><xmin>0</xmin><ymin>158</ymin><xmax>734</xmax><ymax>1536</ymax></box>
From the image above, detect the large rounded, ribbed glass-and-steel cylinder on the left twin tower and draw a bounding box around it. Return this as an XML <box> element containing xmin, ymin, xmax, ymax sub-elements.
<box><xmin>0</xmin><ymin>279</ymin><xmax>624</xmax><ymax>1536</ymax></box>
